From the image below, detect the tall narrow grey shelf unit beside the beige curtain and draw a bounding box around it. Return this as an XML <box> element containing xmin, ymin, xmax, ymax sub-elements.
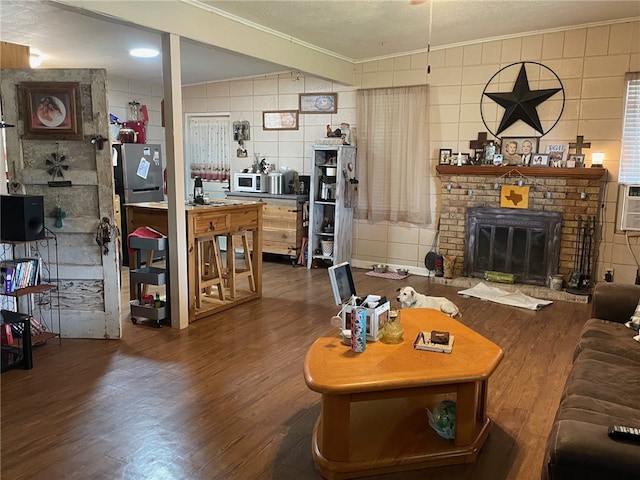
<box><xmin>307</xmin><ymin>145</ymin><xmax>357</xmax><ymax>268</ymax></box>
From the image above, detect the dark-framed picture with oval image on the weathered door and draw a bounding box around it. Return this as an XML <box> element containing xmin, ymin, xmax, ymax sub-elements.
<box><xmin>20</xmin><ymin>82</ymin><xmax>82</xmax><ymax>140</ymax></box>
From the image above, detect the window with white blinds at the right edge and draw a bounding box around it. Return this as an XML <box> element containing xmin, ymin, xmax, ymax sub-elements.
<box><xmin>618</xmin><ymin>72</ymin><xmax>640</xmax><ymax>184</ymax></box>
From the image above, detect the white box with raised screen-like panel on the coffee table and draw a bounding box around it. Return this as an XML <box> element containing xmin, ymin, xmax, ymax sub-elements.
<box><xmin>329</xmin><ymin>262</ymin><xmax>391</xmax><ymax>342</ymax></box>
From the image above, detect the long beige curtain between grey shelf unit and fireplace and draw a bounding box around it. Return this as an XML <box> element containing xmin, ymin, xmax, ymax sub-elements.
<box><xmin>355</xmin><ymin>85</ymin><xmax>431</xmax><ymax>225</ymax></box>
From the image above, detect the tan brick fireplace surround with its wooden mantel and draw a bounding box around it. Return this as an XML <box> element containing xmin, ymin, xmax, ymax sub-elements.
<box><xmin>436</xmin><ymin>165</ymin><xmax>606</xmax><ymax>282</ymax></box>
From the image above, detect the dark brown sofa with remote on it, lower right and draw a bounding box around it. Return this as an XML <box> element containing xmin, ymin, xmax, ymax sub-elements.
<box><xmin>542</xmin><ymin>283</ymin><xmax>640</xmax><ymax>480</ymax></box>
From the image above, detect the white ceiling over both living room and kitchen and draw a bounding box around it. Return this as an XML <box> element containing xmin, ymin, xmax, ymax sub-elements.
<box><xmin>0</xmin><ymin>0</ymin><xmax>640</xmax><ymax>85</ymax></box>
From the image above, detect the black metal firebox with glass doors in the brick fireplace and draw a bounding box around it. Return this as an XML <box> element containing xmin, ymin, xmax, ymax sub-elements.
<box><xmin>464</xmin><ymin>207</ymin><xmax>562</xmax><ymax>285</ymax></box>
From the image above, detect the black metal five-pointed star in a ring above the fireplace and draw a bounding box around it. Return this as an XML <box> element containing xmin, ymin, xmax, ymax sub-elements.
<box><xmin>481</xmin><ymin>62</ymin><xmax>564</xmax><ymax>137</ymax></box>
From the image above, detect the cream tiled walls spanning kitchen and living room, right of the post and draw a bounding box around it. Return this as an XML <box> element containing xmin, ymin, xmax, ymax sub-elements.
<box><xmin>172</xmin><ymin>21</ymin><xmax>640</xmax><ymax>283</ymax></box>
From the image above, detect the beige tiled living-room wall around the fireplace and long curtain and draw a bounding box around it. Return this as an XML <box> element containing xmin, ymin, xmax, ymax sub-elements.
<box><xmin>353</xmin><ymin>21</ymin><xmax>640</xmax><ymax>283</ymax></box>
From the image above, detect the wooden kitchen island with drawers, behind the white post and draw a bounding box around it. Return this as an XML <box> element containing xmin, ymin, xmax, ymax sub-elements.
<box><xmin>125</xmin><ymin>199</ymin><xmax>263</xmax><ymax>322</ymax></box>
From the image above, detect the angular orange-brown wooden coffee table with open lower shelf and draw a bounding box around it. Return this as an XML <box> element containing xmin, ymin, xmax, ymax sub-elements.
<box><xmin>304</xmin><ymin>309</ymin><xmax>503</xmax><ymax>480</ymax></box>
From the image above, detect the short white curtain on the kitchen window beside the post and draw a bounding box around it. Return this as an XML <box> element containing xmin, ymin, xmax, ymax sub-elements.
<box><xmin>188</xmin><ymin>117</ymin><xmax>231</xmax><ymax>181</ymax></box>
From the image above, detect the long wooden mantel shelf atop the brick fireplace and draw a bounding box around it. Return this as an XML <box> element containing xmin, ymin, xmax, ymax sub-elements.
<box><xmin>436</xmin><ymin>165</ymin><xmax>607</xmax><ymax>180</ymax></box>
